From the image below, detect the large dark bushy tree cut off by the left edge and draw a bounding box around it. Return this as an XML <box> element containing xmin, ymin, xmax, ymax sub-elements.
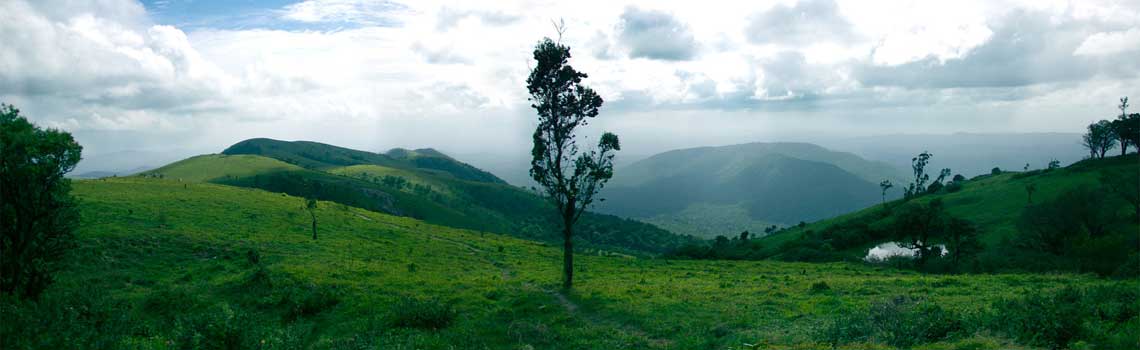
<box><xmin>0</xmin><ymin>104</ymin><xmax>83</xmax><ymax>299</ymax></box>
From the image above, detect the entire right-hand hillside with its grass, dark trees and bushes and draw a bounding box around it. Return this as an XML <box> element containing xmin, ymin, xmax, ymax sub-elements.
<box><xmin>743</xmin><ymin>155</ymin><xmax>1140</xmax><ymax>277</ymax></box>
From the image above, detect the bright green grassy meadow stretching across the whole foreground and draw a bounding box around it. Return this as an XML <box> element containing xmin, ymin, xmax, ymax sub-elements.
<box><xmin>0</xmin><ymin>178</ymin><xmax>1140</xmax><ymax>349</ymax></box>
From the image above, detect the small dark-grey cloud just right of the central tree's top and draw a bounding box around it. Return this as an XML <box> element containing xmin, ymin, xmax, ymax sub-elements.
<box><xmin>618</xmin><ymin>7</ymin><xmax>697</xmax><ymax>60</ymax></box>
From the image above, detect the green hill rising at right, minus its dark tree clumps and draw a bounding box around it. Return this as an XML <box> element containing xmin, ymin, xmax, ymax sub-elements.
<box><xmin>757</xmin><ymin>154</ymin><xmax>1140</xmax><ymax>272</ymax></box>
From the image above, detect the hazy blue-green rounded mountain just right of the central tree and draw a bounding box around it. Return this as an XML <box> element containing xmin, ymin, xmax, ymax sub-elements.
<box><xmin>600</xmin><ymin>143</ymin><xmax>903</xmax><ymax>237</ymax></box>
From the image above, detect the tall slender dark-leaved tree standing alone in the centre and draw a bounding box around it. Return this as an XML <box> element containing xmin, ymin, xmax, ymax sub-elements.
<box><xmin>527</xmin><ymin>36</ymin><xmax>621</xmax><ymax>290</ymax></box>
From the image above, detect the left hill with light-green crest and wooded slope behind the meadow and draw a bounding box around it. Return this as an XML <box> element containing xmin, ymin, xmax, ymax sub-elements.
<box><xmin>149</xmin><ymin>141</ymin><xmax>692</xmax><ymax>253</ymax></box>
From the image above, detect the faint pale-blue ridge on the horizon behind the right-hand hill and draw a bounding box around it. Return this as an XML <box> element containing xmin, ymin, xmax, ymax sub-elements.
<box><xmin>820</xmin><ymin>132</ymin><xmax>1085</xmax><ymax>177</ymax></box>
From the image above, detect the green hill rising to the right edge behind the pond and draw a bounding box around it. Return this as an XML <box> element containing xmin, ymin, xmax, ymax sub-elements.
<box><xmin>756</xmin><ymin>154</ymin><xmax>1140</xmax><ymax>275</ymax></box>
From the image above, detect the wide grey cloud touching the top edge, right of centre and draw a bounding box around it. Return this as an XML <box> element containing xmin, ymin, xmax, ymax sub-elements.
<box><xmin>744</xmin><ymin>0</ymin><xmax>855</xmax><ymax>46</ymax></box>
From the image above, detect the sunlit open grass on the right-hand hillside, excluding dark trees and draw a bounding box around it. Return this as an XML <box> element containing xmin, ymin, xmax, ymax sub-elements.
<box><xmin>763</xmin><ymin>155</ymin><xmax>1138</xmax><ymax>259</ymax></box>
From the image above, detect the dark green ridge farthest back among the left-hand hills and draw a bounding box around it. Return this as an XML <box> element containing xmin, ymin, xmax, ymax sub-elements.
<box><xmin>222</xmin><ymin>138</ymin><xmax>506</xmax><ymax>184</ymax></box>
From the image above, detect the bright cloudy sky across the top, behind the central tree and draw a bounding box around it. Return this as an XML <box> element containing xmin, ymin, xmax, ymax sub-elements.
<box><xmin>0</xmin><ymin>0</ymin><xmax>1140</xmax><ymax>159</ymax></box>
